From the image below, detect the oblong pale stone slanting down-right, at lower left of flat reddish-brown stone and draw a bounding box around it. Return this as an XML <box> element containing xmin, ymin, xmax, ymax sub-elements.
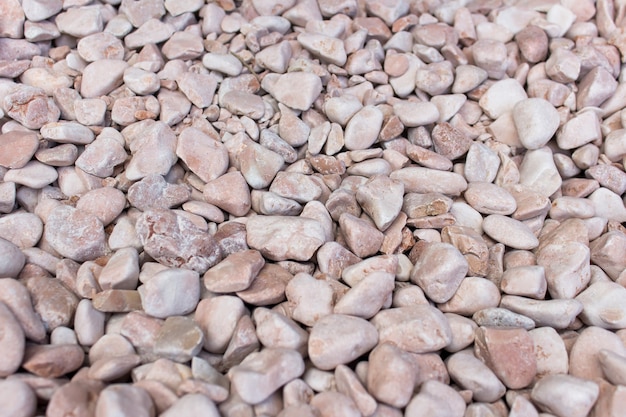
<box><xmin>446</xmin><ymin>350</ymin><xmax>506</xmax><ymax>403</ymax></box>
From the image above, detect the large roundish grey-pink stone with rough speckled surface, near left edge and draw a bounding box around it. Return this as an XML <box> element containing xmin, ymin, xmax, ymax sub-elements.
<box><xmin>44</xmin><ymin>206</ymin><xmax>105</xmax><ymax>262</ymax></box>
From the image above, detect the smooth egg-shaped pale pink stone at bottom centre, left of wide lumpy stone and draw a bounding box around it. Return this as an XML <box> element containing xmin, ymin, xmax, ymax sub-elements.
<box><xmin>308</xmin><ymin>313</ymin><xmax>380</xmax><ymax>370</ymax></box>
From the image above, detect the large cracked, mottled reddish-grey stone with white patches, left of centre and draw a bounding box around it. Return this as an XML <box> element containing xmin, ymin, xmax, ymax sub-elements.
<box><xmin>136</xmin><ymin>210</ymin><xmax>222</xmax><ymax>273</ymax></box>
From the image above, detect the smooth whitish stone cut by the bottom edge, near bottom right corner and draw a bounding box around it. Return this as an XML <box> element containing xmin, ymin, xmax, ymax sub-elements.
<box><xmin>530</xmin><ymin>374</ymin><xmax>599</xmax><ymax>417</ymax></box>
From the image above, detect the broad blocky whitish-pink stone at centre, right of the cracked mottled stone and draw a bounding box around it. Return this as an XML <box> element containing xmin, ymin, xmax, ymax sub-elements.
<box><xmin>246</xmin><ymin>216</ymin><xmax>326</xmax><ymax>261</ymax></box>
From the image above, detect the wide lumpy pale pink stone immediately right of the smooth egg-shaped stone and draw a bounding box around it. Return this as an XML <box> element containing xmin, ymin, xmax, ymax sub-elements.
<box><xmin>371</xmin><ymin>305</ymin><xmax>452</xmax><ymax>353</ymax></box>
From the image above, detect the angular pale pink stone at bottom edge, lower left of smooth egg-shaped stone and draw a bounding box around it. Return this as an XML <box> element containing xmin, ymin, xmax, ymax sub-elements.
<box><xmin>230</xmin><ymin>348</ymin><xmax>304</xmax><ymax>404</ymax></box>
